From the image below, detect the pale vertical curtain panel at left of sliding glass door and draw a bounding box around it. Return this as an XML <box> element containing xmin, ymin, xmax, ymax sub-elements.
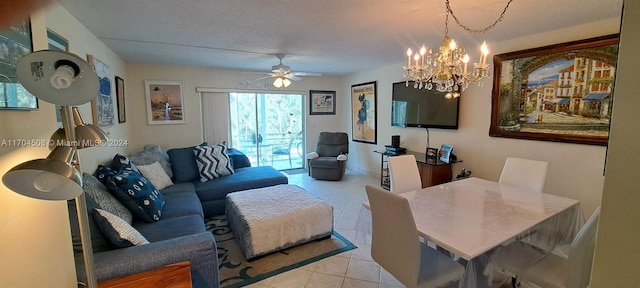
<box><xmin>201</xmin><ymin>92</ymin><xmax>232</xmax><ymax>147</ymax></box>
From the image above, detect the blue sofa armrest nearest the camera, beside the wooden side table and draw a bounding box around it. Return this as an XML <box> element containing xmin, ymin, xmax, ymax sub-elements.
<box><xmin>94</xmin><ymin>232</ymin><xmax>220</xmax><ymax>287</ymax></box>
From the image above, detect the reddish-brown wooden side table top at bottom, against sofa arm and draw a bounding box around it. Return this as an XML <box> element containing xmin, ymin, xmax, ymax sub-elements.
<box><xmin>98</xmin><ymin>261</ymin><xmax>192</xmax><ymax>288</ymax></box>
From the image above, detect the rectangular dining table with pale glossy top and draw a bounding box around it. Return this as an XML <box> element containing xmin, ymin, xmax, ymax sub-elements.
<box><xmin>358</xmin><ymin>177</ymin><xmax>582</xmax><ymax>288</ymax></box>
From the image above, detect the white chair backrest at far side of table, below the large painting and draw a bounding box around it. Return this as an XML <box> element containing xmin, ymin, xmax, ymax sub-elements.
<box><xmin>498</xmin><ymin>157</ymin><xmax>549</xmax><ymax>193</ymax></box>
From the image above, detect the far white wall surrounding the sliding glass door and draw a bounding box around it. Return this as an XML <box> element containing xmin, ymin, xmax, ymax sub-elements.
<box><xmin>125</xmin><ymin>63</ymin><xmax>347</xmax><ymax>152</ymax></box>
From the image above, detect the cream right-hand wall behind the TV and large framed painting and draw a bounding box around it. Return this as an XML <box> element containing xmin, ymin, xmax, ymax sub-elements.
<box><xmin>339</xmin><ymin>19</ymin><xmax>620</xmax><ymax>215</ymax></box>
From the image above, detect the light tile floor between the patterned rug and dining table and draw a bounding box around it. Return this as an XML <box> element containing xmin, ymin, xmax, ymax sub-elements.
<box><xmin>247</xmin><ymin>171</ymin><xmax>403</xmax><ymax>288</ymax></box>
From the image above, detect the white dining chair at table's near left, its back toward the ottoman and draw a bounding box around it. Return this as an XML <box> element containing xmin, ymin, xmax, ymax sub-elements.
<box><xmin>365</xmin><ymin>185</ymin><xmax>464</xmax><ymax>288</ymax></box>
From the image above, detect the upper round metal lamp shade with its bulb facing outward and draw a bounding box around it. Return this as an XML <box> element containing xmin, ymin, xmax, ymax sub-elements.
<box><xmin>16</xmin><ymin>50</ymin><xmax>100</xmax><ymax>106</ymax></box>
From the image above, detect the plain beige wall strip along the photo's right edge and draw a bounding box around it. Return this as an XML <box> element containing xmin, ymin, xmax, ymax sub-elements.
<box><xmin>591</xmin><ymin>1</ymin><xmax>640</xmax><ymax>288</ymax></box>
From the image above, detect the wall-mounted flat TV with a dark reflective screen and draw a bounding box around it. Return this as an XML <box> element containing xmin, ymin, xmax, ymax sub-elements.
<box><xmin>391</xmin><ymin>82</ymin><xmax>460</xmax><ymax>130</ymax></box>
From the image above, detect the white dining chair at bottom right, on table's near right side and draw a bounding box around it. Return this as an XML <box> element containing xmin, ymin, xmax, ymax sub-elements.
<box><xmin>491</xmin><ymin>208</ymin><xmax>600</xmax><ymax>288</ymax></box>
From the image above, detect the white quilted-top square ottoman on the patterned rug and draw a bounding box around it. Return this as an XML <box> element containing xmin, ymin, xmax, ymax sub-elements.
<box><xmin>226</xmin><ymin>184</ymin><xmax>333</xmax><ymax>260</ymax></box>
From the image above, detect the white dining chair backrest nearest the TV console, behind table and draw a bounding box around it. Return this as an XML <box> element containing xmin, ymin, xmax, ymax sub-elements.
<box><xmin>388</xmin><ymin>154</ymin><xmax>422</xmax><ymax>194</ymax></box>
